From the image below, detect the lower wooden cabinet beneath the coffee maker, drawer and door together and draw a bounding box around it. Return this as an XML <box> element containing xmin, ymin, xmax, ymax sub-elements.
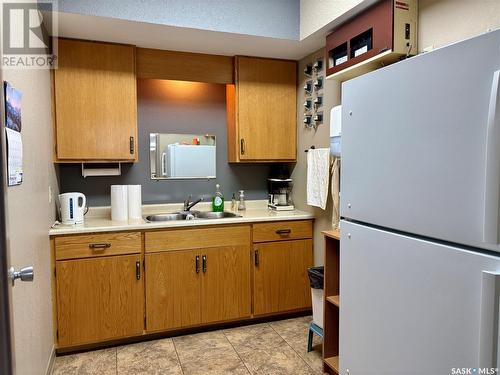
<box><xmin>253</xmin><ymin>221</ymin><xmax>313</xmax><ymax>315</ymax></box>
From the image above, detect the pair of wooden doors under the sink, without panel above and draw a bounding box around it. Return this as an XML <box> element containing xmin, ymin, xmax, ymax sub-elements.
<box><xmin>146</xmin><ymin>245</ymin><xmax>251</xmax><ymax>332</ymax></box>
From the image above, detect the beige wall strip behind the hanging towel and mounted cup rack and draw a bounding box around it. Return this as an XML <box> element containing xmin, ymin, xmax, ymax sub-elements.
<box><xmin>292</xmin><ymin>49</ymin><xmax>340</xmax><ymax>265</ymax></box>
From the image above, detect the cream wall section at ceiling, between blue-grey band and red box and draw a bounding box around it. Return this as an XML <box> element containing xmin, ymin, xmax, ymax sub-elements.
<box><xmin>300</xmin><ymin>0</ymin><xmax>363</xmax><ymax>39</ymax></box>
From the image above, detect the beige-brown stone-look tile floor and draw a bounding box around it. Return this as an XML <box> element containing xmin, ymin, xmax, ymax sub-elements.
<box><xmin>53</xmin><ymin>316</ymin><xmax>322</xmax><ymax>375</ymax></box>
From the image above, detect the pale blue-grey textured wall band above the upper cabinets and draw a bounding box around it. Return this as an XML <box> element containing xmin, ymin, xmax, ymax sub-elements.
<box><xmin>53</xmin><ymin>0</ymin><xmax>300</xmax><ymax>40</ymax></box>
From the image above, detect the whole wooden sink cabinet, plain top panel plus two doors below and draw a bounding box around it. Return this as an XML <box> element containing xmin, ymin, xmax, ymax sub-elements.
<box><xmin>146</xmin><ymin>226</ymin><xmax>251</xmax><ymax>332</ymax></box>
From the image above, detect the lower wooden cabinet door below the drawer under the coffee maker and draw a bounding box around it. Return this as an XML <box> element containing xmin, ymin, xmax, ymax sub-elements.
<box><xmin>254</xmin><ymin>239</ymin><xmax>313</xmax><ymax>315</ymax></box>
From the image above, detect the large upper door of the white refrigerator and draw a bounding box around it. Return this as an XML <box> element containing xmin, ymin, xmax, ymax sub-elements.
<box><xmin>341</xmin><ymin>30</ymin><xmax>500</xmax><ymax>251</ymax></box>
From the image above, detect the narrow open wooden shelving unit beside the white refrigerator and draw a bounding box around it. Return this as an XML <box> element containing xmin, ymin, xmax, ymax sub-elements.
<box><xmin>323</xmin><ymin>230</ymin><xmax>340</xmax><ymax>374</ymax></box>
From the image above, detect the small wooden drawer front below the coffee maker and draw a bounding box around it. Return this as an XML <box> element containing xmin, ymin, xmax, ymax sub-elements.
<box><xmin>253</xmin><ymin>220</ymin><xmax>312</xmax><ymax>242</ymax></box>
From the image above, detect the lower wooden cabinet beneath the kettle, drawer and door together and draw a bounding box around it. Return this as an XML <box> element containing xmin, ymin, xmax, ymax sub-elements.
<box><xmin>54</xmin><ymin>232</ymin><xmax>144</xmax><ymax>347</ymax></box>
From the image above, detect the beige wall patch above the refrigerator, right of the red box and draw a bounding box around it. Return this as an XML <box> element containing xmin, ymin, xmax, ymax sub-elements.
<box><xmin>418</xmin><ymin>0</ymin><xmax>500</xmax><ymax>51</ymax></box>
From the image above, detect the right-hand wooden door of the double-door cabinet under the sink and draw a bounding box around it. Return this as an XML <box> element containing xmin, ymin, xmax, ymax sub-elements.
<box><xmin>200</xmin><ymin>244</ymin><xmax>251</xmax><ymax>323</ymax></box>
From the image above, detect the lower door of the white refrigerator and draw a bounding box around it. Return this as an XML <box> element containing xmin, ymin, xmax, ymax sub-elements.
<box><xmin>340</xmin><ymin>221</ymin><xmax>500</xmax><ymax>375</ymax></box>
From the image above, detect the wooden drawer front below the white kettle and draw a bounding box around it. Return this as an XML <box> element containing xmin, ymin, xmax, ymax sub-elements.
<box><xmin>54</xmin><ymin>232</ymin><xmax>142</xmax><ymax>260</ymax></box>
